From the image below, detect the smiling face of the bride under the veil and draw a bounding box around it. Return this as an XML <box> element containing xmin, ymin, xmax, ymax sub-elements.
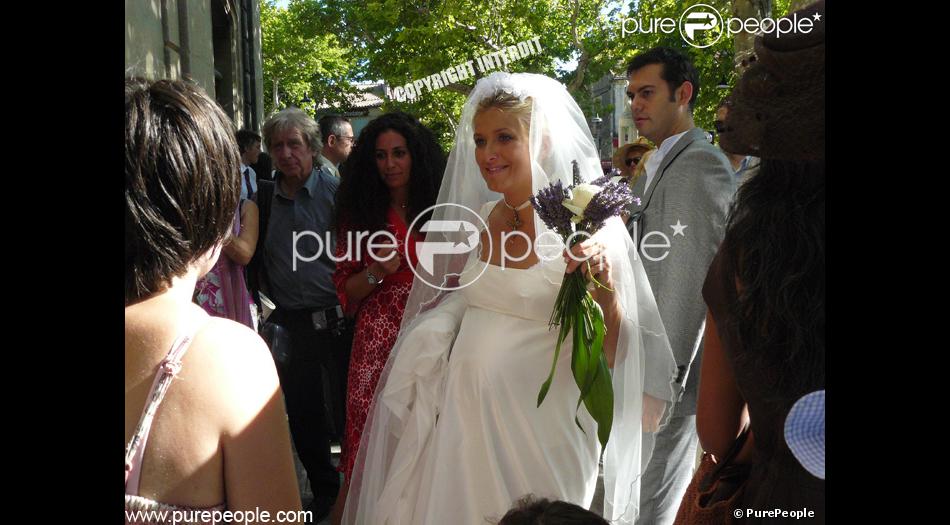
<box><xmin>473</xmin><ymin>107</ymin><xmax>531</xmax><ymax>194</ymax></box>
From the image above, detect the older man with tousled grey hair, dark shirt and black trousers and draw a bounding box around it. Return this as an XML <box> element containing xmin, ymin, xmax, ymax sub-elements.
<box><xmin>249</xmin><ymin>108</ymin><xmax>353</xmax><ymax>522</ymax></box>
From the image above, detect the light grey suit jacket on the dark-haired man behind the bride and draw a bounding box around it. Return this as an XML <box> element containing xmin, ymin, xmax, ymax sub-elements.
<box><xmin>627</xmin><ymin>128</ymin><xmax>735</xmax><ymax>416</ymax></box>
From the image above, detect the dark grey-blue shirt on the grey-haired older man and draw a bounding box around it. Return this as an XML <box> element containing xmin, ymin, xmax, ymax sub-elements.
<box><xmin>264</xmin><ymin>167</ymin><xmax>340</xmax><ymax>310</ymax></box>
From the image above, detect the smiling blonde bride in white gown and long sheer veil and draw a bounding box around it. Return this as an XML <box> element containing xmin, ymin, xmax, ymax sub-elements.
<box><xmin>343</xmin><ymin>73</ymin><xmax>676</xmax><ymax>525</ymax></box>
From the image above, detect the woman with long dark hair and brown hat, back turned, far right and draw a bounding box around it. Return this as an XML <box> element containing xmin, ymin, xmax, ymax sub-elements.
<box><xmin>677</xmin><ymin>1</ymin><xmax>825</xmax><ymax>524</ymax></box>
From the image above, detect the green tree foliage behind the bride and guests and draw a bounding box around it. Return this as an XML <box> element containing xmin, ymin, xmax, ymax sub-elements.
<box><xmin>261</xmin><ymin>0</ymin><xmax>790</xmax><ymax>145</ymax></box>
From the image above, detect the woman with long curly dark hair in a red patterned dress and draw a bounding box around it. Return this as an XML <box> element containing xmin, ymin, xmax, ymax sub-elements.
<box><xmin>333</xmin><ymin>112</ymin><xmax>445</xmax><ymax>516</ymax></box>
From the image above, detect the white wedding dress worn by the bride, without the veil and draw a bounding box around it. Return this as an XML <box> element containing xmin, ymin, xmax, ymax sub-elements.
<box><xmin>356</xmin><ymin>203</ymin><xmax>600</xmax><ymax>525</ymax></box>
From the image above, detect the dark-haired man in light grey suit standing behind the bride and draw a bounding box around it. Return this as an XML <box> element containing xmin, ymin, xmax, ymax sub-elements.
<box><xmin>627</xmin><ymin>48</ymin><xmax>735</xmax><ymax>525</ymax></box>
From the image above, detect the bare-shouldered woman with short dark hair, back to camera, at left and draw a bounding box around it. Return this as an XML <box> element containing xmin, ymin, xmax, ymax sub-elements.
<box><xmin>125</xmin><ymin>79</ymin><xmax>300</xmax><ymax>523</ymax></box>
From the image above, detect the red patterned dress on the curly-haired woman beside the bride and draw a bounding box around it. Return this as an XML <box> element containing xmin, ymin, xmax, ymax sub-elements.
<box><xmin>333</xmin><ymin>208</ymin><xmax>424</xmax><ymax>482</ymax></box>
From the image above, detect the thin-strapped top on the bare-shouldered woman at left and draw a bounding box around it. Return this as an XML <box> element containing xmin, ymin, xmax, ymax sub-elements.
<box><xmin>125</xmin><ymin>335</ymin><xmax>227</xmax><ymax>525</ymax></box>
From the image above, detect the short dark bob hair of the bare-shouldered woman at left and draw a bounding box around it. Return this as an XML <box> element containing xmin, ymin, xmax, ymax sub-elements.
<box><xmin>125</xmin><ymin>78</ymin><xmax>241</xmax><ymax>305</ymax></box>
